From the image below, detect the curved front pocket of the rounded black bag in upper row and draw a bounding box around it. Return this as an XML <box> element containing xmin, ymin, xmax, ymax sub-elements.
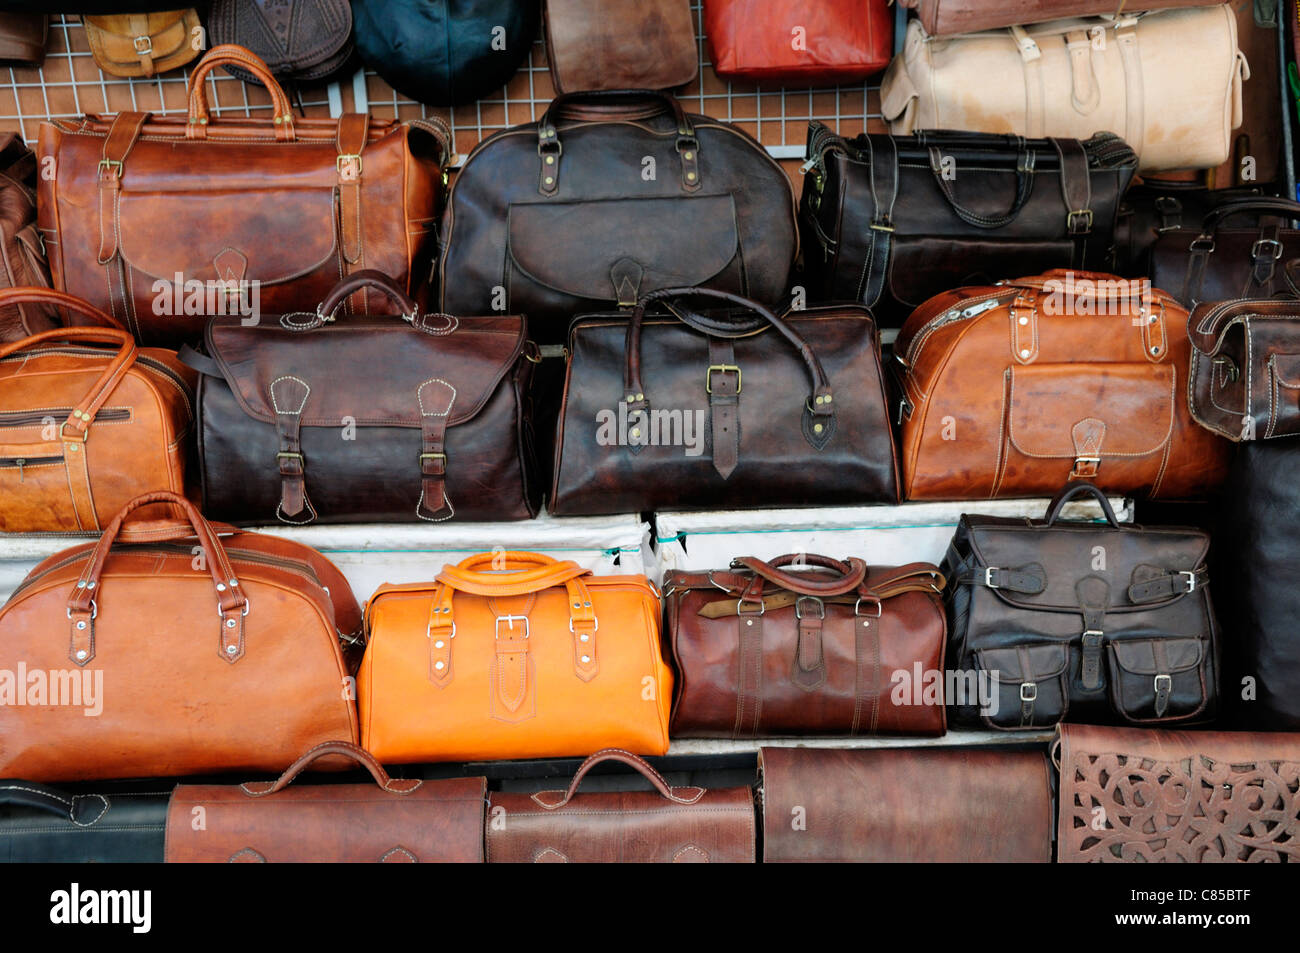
<box><xmin>507</xmin><ymin>197</ymin><xmax>740</xmax><ymax>300</ymax></box>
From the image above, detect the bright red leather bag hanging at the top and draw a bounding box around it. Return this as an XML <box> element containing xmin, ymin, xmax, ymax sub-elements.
<box><xmin>703</xmin><ymin>0</ymin><xmax>893</xmax><ymax>86</ymax></box>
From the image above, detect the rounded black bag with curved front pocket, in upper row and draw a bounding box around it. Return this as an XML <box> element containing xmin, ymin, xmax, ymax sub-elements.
<box><xmin>438</xmin><ymin>91</ymin><xmax>798</xmax><ymax>343</ymax></box>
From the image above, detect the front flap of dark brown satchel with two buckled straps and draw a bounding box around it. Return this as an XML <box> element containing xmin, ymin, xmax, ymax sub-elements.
<box><xmin>205</xmin><ymin>316</ymin><xmax>525</xmax><ymax>426</ymax></box>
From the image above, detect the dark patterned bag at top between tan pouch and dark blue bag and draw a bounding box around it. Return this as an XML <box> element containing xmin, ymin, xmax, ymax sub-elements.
<box><xmin>208</xmin><ymin>0</ymin><xmax>352</xmax><ymax>83</ymax></box>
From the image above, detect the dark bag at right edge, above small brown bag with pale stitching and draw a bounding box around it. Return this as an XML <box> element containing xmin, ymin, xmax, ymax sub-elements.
<box><xmin>1151</xmin><ymin>196</ymin><xmax>1300</xmax><ymax>308</ymax></box>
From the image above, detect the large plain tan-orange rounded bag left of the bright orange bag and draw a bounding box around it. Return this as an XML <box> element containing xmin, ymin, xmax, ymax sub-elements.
<box><xmin>0</xmin><ymin>490</ymin><xmax>360</xmax><ymax>781</ymax></box>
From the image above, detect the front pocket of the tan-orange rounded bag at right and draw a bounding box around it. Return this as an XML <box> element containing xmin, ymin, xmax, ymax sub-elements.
<box><xmin>1008</xmin><ymin>364</ymin><xmax>1178</xmax><ymax>459</ymax></box>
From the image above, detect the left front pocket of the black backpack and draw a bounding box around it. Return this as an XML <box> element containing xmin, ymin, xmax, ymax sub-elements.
<box><xmin>975</xmin><ymin>642</ymin><xmax>1070</xmax><ymax>731</ymax></box>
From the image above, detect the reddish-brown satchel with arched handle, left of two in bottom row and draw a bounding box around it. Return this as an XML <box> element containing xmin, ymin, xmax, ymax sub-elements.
<box><xmin>166</xmin><ymin>741</ymin><xmax>488</xmax><ymax>863</ymax></box>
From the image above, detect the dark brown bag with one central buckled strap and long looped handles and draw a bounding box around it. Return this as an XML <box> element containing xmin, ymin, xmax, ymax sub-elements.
<box><xmin>549</xmin><ymin>287</ymin><xmax>898</xmax><ymax>516</ymax></box>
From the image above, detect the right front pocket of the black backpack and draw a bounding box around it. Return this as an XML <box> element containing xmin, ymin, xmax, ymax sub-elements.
<box><xmin>1109</xmin><ymin>638</ymin><xmax>1206</xmax><ymax>722</ymax></box>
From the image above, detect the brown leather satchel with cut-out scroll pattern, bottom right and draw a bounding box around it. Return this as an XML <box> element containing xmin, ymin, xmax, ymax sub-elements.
<box><xmin>1053</xmin><ymin>724</ymin><xmax>1300</xmax><ymax>863</ymax></box>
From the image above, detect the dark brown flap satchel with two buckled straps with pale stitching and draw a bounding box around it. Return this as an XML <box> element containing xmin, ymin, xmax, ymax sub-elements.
<box><xmin>185</xmin><ymin>272</ymin><xmax>538</xmax><ymax>524</ymax></box>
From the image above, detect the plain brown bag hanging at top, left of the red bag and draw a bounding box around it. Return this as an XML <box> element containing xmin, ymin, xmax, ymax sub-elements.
<box><xmin>545</xmin><ymin>0</ymin><xmax>699</xmax><ymax>92</ymax></box>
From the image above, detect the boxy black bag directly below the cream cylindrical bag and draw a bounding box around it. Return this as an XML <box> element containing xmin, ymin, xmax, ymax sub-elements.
<box><xmin>800</xmin><ymin>122</ymin><xmax>1136</xmax><ymax>328</ymax></box>
